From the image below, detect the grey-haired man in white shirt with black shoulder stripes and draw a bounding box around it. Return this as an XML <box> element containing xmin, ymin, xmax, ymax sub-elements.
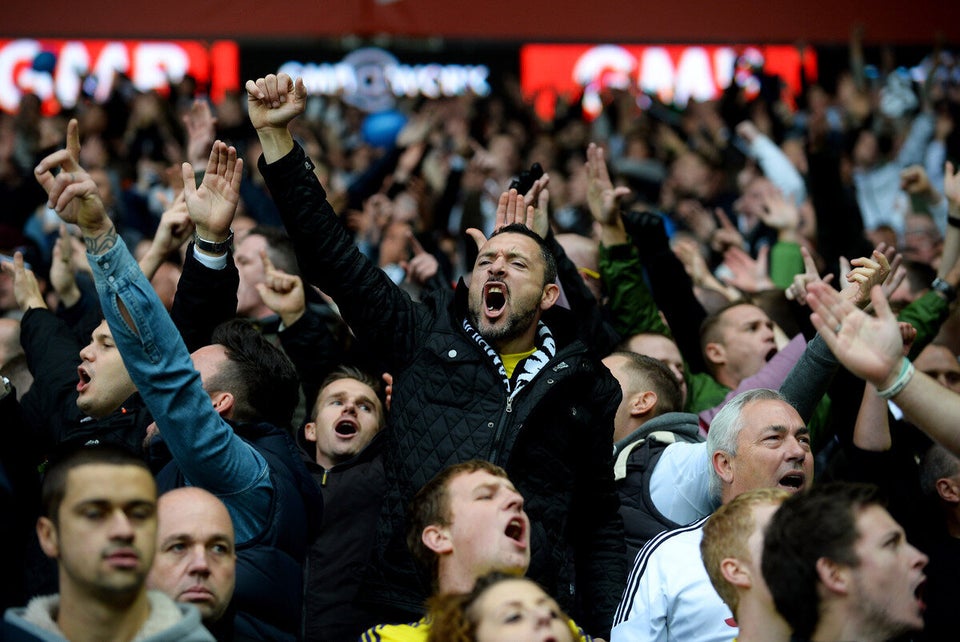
<box><xmin>610</xmin><ymin>388</ymin><xmax>813</xmax><ymax>642</ymax></box>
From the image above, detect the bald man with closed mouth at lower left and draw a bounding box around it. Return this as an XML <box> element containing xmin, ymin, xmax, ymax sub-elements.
<box><xmin>147</xmin><ymin>486</ymin><xmax>237</xmax><ymax>639</ymax></box>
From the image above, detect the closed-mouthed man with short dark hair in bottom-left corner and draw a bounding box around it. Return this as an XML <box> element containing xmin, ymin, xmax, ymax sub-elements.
<box><xmin>0</xmin><ymin>446</ymin><xmax>213</xmax><ymax>642</ymax></box>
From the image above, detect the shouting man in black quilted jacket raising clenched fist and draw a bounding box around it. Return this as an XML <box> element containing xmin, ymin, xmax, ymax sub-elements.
<box><xmin>247</xmin><ymin>74</ymin><xmax>626</xmax><ymax>636</ymax></box>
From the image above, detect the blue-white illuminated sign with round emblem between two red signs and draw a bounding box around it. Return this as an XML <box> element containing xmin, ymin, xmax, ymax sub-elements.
<box><xmin>280</xmin><ymin>47</ymin><xmax>490</xmax><ymax>112</ymax></box>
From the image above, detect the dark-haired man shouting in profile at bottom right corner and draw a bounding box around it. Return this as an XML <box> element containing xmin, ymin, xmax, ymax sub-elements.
<box><xmin>763</xmin><ymin>482</ymin><xmax>927</xmax><ymax>642</ymax></box>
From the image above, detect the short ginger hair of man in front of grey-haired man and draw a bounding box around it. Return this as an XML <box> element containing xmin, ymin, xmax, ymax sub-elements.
<box><xmin>700</xmin><ymin>488</ymin><xmax>790</xmax><ymax>617</ymax></box>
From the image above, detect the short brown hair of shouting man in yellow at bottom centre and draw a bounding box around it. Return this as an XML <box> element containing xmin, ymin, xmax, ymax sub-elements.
<box><xmin>407</xmin><ymin>459</ymin><xmax>509</xmax><ymax>580</ymax></box>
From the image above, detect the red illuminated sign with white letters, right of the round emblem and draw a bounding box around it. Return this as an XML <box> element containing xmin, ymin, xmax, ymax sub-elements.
<box><xmin>520</xmin><ymin>45</ymin><xmax>816</xmax><ymax>119</ymax></box>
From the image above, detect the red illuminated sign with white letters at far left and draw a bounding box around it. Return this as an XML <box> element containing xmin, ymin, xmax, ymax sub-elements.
<box><xmin>0</xmin><ymin>39</ymin><xmax>240</xmax><ymax>114</ymax></box>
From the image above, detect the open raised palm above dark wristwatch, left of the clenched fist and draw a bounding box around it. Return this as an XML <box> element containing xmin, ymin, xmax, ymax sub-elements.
<box><xmin>182</xmin><ymin>140</ymin><xmax>243</xmax><ymax>242</ymax></box>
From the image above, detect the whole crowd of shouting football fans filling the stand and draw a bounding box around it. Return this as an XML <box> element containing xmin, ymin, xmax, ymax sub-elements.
<box><xmin>0</xmin><ymin>35</ymin><xmax>960</xmax><ymax>642</ymax></box>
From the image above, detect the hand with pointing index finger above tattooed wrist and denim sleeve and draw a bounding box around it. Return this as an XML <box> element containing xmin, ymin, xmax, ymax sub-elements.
<box><xmin>34</xmin><ymin>118</ymin><xmax>113</xmax><ymax>238</ymax></box>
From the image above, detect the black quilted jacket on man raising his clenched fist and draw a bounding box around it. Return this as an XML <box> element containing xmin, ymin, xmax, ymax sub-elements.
<box><xmin>260</xmin><ymin>146</ymin><xmax>626</xmax><ymax>636</ymax></box>
